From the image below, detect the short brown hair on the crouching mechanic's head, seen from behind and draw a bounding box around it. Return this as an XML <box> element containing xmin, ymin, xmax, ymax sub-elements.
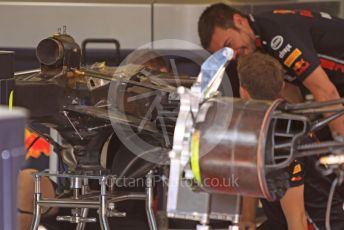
<box><xmin>237</xmin><ymin>51</ymin><xmax>284</xmax><ymax>100</ymax></box>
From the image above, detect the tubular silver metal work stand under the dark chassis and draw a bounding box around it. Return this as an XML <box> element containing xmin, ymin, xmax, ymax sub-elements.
<box><xmin>31</xmin><ymin>171</ymin><xmax>158</xmax><ymax>230</ymax></box>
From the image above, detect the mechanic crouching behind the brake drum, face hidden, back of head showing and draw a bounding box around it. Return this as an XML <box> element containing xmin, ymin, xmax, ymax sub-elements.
<box><xmin>238</xmin><ymin>52</ymin><xmax>344</xmax><ymax>230</ymax></box>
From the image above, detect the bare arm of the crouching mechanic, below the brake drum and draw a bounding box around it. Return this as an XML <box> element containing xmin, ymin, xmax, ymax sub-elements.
<box><xmin>280</xmin><ymin>185</ymin><xmax>308</xmax><ymax>230</ymax></box>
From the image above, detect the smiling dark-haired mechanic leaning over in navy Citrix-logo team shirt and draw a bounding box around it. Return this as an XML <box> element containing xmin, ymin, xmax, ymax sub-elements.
<box><xmin>198</xmin><ymin>3</ymin><xmax>344</xmax><ymax>136</ymax></box>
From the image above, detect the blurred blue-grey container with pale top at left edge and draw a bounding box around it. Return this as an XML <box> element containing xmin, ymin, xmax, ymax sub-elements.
<box><xmin>0</xmin><ymin>106</ymin><xmax>27</xmax><ymax>230</ymax></box>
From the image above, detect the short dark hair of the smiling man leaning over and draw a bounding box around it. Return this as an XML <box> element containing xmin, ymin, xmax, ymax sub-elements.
<box><xmin>198</xmin><ymin>3</ymin><xmax>246</xmax><ymax>49</ymax></box>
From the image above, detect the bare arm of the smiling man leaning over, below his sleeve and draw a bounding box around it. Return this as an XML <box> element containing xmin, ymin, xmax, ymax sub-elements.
<box><xmin>303</xmin><ymin>66</ymin><xmax>344</xmax><ymax>136</ymax></box>
